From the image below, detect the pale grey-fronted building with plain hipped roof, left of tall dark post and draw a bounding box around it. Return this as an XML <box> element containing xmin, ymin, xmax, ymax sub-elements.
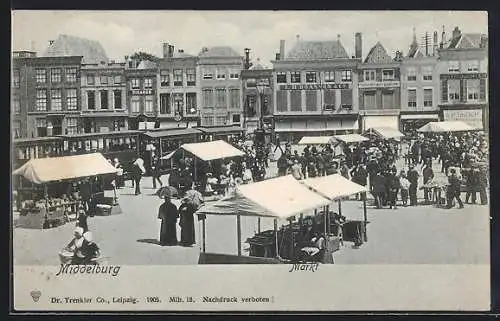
<box><xmin>198</xmin><ymin>47</ymin><xmax>243</xmax><ymax>127</ymax></box>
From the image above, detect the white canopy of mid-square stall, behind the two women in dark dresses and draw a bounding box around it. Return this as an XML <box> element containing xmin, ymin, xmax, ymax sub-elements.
<box><xmin>162</xmin><ymin>140</ymin><xmax>245</xmax><ymax>161</ymax></box>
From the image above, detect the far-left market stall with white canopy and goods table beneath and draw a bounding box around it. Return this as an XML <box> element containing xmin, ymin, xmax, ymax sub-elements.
<box><xmin>13</xmin><ymin>153</ymin><xmax>121</xmax><ymax>228</ymax></box>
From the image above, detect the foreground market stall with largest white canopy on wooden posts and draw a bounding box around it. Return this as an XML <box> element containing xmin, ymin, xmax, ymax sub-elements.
<box><xmin>197</xmin><ymin>175</ymin><xmax>333</xmax><ymax>264</ymax></box>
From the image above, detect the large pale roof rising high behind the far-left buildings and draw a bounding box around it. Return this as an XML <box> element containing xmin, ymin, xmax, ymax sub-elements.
<box><xmin>43</xmin><ymin>35</ymin><xmax>108</xmax><ymax>64</ymax></box>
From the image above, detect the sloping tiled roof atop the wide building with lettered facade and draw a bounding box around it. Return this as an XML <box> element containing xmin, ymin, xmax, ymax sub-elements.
<box><xmin>286</xmin><ymin>40</ymin><xmax>349</xmax><ymax>60</ymax></box>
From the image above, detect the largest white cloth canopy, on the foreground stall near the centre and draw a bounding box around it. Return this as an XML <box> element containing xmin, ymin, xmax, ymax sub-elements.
<box><xmin>197</xmin><ymin>175</ymin><xmax>330</xmax><ymax>218</ymax></box>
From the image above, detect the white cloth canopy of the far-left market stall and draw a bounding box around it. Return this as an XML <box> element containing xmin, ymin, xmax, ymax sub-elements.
<box><xmin>13</xmin><ymin>153</ymin><xmax>116</xmax><ymax>184</ymax></box>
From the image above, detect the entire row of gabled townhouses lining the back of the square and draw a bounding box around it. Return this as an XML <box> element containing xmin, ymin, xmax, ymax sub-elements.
<box><xmin>11</xmin><ymin>28</ymin><xmax>488</xmax><ymax>139</ymax></box>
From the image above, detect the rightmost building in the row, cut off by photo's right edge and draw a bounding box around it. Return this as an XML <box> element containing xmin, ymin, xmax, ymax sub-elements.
<box><xmin>436</xmin><ymin>27</ymin><xmax>489</xmax><ymax>129</ymax></box>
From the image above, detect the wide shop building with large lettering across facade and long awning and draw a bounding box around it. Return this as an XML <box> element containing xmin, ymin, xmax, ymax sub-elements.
<box><xmin>272</xmin><ymin>36</ymin><xmax>361</xmax><ymax>140</ymax></box>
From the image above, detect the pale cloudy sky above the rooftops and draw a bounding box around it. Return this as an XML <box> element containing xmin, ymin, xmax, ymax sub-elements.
<box><xmin>12</xmin><ymin>11</ymin><xmax>488</xmax><ymax>67</ymax></box>
